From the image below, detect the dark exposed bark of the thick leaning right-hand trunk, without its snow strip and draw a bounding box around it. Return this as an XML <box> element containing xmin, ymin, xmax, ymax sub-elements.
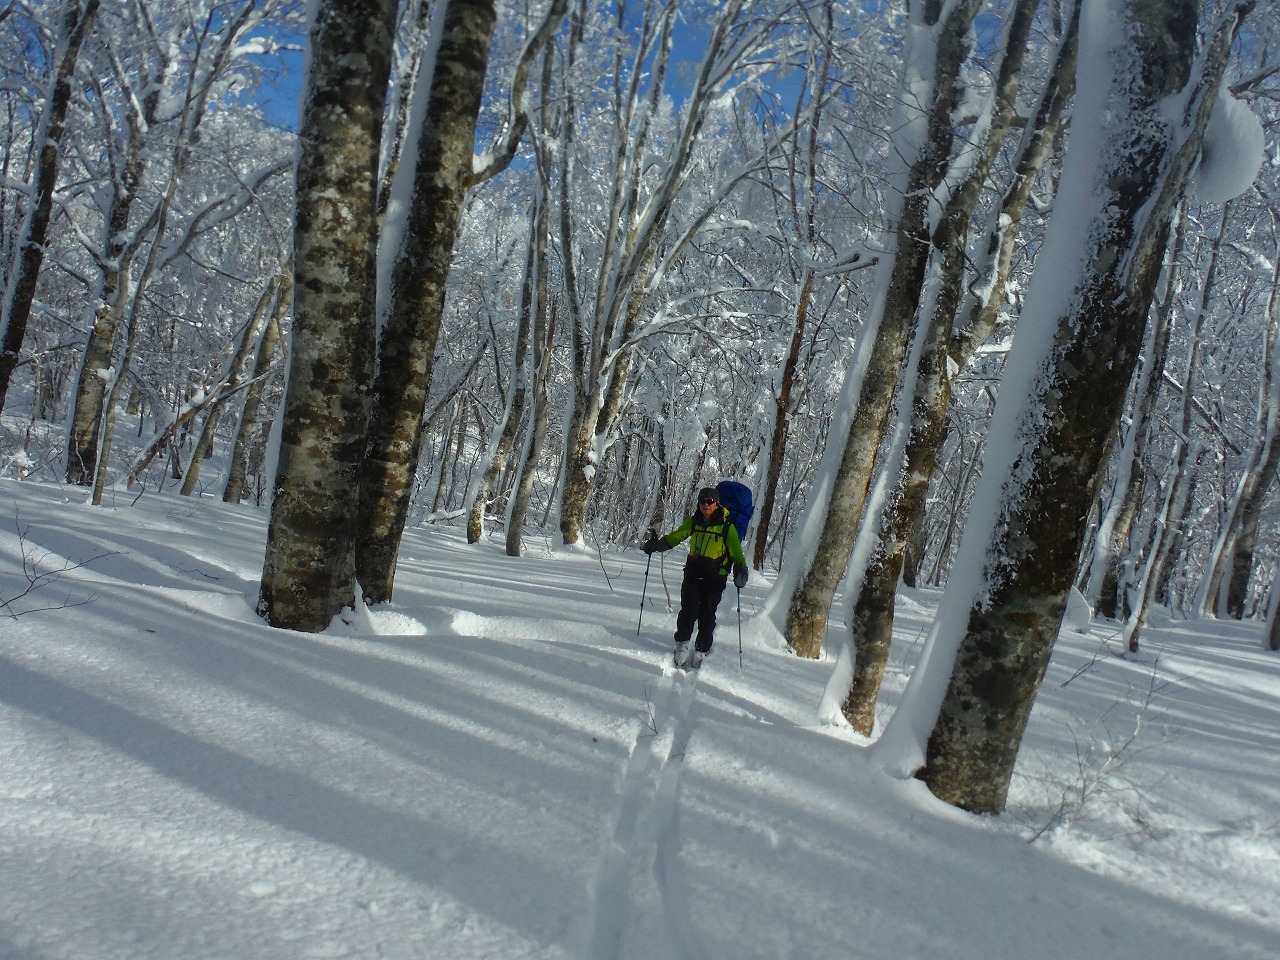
<box><xmin>919</xmin><ymin>0</ymin><xmax>1244</xmax><ymax>813</ymax></box>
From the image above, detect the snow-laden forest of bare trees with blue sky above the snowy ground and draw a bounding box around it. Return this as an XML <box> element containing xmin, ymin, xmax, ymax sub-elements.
<box><xmin>0</xmin><ymin>0</ymin><xmax>1280</xmax><ymax>813</ymax></box>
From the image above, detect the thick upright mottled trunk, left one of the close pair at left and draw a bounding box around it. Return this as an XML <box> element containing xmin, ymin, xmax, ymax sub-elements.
<box><xmin>257</xmin><ymin>0</ymin><xmax>396</xmax><ymax>632</ymax></box>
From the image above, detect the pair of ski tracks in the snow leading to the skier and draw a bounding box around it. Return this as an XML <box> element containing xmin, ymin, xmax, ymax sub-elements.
<box><xmin>584</xmin><ymin>666</ymin><xmax>707</xmax><ymax>960</ymax></box>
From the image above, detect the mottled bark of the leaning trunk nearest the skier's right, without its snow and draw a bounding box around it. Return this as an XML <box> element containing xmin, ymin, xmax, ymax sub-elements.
<box><xmin>783</xmin><ymin>0</ymin><xmax>980</xmax><ymax>657</ymax></box>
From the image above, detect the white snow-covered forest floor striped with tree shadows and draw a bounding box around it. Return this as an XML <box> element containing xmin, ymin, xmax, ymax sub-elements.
<box><xmin>0</xmin><ymin>480</ymin><xmax>1280</xmax><ymax>960</ymax></box>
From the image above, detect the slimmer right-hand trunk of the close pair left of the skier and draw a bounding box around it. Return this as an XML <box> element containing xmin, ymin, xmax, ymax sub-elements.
<box><xmin>356</xmin><ymin>0</ymin><xmax>497</xmax><ymax>603</ymax></box>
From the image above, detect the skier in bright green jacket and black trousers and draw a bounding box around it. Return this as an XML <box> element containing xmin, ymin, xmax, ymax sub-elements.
<box><xmin>643</xmin><ymin>486</ymin><xmax>746</xmax><ymax>669</ymax></box>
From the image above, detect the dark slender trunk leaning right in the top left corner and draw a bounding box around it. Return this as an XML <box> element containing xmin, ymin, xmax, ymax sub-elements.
<box><xmin>0</xmin><ymin>0</ymin><xmax>99</xmax><ymax>412</ymax></box>
